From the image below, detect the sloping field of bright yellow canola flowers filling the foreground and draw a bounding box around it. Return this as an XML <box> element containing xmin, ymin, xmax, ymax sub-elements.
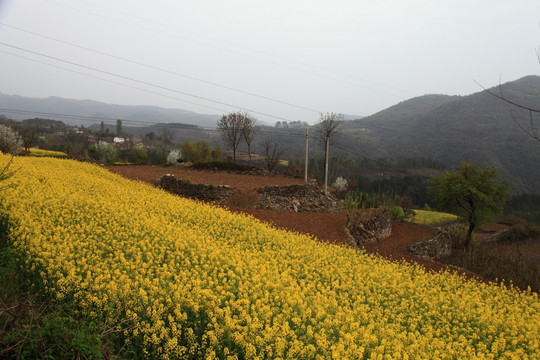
<box><xmin>0</xmin><ymin>155</ymin><xmax>540</xmax><ymax>359</ymax></box>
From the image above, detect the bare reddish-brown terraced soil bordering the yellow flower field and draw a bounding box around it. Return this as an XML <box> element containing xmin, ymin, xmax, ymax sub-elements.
<box><xmin>107</xmin><ymin>166</ymin><xmax>471</xmax><ymax>276</ymax></box>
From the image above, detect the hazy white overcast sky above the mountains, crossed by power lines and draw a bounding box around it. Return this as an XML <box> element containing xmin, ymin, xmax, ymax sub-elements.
<box><xmin>0</xmin><ymin>0</ymin><xmax>540</xmax><ymax>123</ymax></box>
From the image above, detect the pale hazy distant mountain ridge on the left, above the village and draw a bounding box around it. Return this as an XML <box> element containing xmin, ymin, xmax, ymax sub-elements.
<box><xmin>0</xmin><ymin>94</ymin><xmax>220</xmax><ymax>127</ymax></box>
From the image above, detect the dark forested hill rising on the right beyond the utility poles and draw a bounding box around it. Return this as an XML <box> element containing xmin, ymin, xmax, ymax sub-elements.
<box><xmin>344</xmin><ymin>76</ymin><xmax>540</xmax><ymax>193</ymax></box>
